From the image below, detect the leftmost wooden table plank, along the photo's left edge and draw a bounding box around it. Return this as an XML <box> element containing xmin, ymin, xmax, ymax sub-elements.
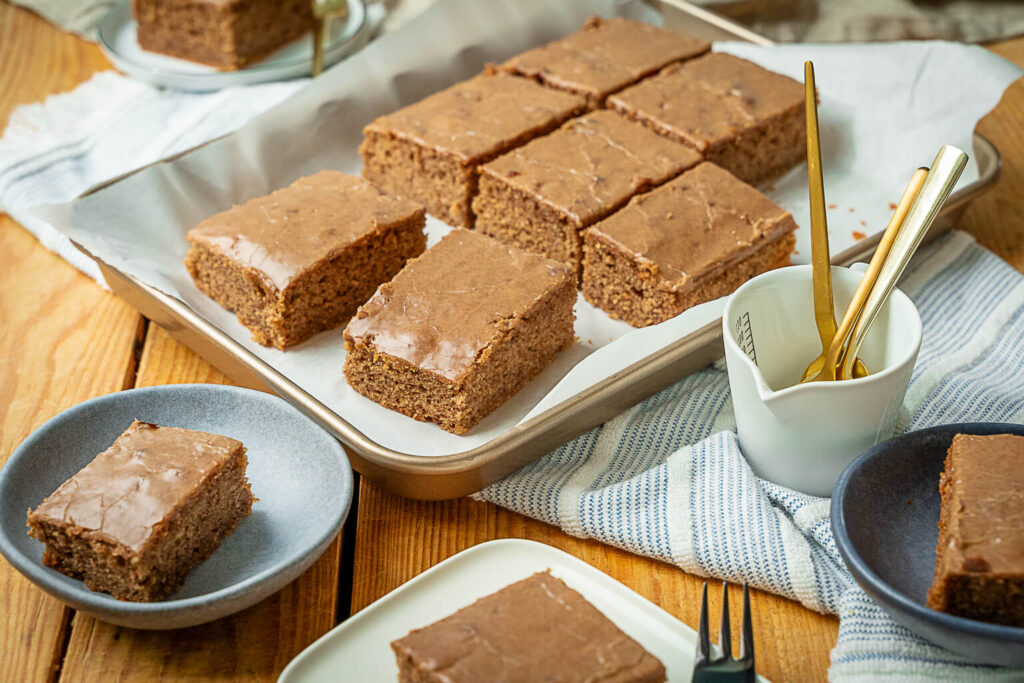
<box><xmin>0</xmin><ymin>3</ymin><xmax>142</xmax><ymax>681</ymax></box>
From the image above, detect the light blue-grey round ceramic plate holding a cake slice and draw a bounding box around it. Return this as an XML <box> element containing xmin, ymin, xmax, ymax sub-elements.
<box><xmin>0</xmin><ymin>384</ymin><xmax>352</xmax><ymax>629</ymax></box>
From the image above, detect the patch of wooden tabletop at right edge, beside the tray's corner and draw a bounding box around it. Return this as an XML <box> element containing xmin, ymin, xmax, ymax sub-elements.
<box><xmin>961</xmin><ymin>38</ymin><xmax>1024</xmax><ymax>271</ymax></box>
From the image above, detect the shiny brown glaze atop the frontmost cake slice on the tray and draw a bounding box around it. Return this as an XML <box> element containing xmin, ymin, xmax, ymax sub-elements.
<box><xmin>345</xmin><ymin>229</ymin><xmax>573</xmax><ymax>381</ymax></box>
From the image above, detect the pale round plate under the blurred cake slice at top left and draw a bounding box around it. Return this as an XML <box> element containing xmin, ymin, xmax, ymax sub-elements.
<box><xmin>99</xmin><ymin>0</ymin><xmax>374</xmax><ymax>90</ymax></box>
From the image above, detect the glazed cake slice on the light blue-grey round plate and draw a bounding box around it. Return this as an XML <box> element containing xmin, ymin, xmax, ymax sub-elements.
<box><xmin>28</xmin><ymin>420</ymin><xmax>254</xmax><ymax>602</ymax></box>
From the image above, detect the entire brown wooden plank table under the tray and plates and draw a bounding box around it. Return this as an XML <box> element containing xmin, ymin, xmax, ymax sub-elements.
<box><xmin>0</xmin><ymin>3</ymin><xmax>1024</xmax><ymax>681</ymax></box>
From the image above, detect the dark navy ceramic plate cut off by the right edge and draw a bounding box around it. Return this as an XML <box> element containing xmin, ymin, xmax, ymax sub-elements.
<box><xmin>831</xmin><ymin>422</ymin><xmax>1024</xmax><ymax>667</ymax></box>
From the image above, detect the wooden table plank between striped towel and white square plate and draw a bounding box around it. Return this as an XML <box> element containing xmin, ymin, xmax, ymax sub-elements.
<box><xmin>352</xmin><ymin>478</ymin><xmax>839</xmax><ymax>681</ymax></box>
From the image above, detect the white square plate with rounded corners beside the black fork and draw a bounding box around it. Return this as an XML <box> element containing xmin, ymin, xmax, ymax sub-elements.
<box><xmin>278</xmin><ymin>539</ymin><xmax>763</xmax><ymax>683</ymax></box>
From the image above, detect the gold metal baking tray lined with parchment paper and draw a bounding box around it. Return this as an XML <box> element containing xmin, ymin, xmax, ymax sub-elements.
<box><xmin>72</xmin><ymin>0</ymin><xmax>1000</xmax><ymax>500</ymax></box>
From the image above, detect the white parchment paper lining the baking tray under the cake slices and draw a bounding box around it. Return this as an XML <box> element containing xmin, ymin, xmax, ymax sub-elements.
<box><xmin>41</xmin><ymin>0</ymin><xmax>1020</xmax><ymax>456</ymax></box>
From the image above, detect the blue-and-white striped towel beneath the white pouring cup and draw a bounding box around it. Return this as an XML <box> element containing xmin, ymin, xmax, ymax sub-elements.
<box><xmin>477</xmin><ymin>232</ymin><xmax>1024</xmax><ymax>681</ymax></box>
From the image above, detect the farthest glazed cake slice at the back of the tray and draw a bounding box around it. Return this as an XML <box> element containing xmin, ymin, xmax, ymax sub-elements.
<box><xmin>502</xmin><ymin>16</ymin><xmax>711</xmax><ymax>108</ymax></box>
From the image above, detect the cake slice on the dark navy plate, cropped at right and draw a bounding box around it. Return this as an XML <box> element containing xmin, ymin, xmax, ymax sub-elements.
<box><xmin>928</xmin><ymin>434</ymin><xmax>1024</xmax><ymax>627</ymax></box>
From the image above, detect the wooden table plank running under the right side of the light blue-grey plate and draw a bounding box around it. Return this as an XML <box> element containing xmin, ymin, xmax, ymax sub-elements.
<box><xmin>61</xmin><ymin>325</ymin><xmax>341</xmax><ymax>681</ymax></box>
